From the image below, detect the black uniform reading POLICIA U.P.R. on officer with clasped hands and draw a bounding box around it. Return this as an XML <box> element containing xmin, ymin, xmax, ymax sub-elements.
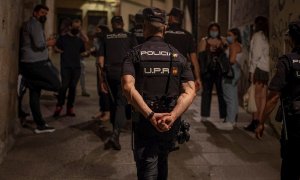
<box><xmin>123</xmin><ymin>36</ymin><xmax>194</xmax><ymax>179</ymax></box>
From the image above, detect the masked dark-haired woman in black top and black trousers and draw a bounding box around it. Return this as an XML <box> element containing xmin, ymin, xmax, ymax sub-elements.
<box><xmin>198</xmin><ymin>23</ymin><xmax>226</xmax><ymax>122</ymax></box>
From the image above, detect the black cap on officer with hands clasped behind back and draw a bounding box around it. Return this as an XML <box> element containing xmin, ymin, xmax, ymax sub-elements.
<box><xmin>143</xmin><ymin>8</ymin><xmax>166</xmax><ymax>24</ymax></box>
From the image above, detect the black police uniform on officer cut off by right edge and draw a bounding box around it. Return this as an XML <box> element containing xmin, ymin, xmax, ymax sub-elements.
<box><xmin>269</xmin><ymin>48</ymin><xmax>300</xmax><ymax>180</ymax></box>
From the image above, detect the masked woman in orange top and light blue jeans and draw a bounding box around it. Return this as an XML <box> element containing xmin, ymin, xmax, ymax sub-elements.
<box><xmin>219</xmin><ymin>28</ymin><xmax>242</xmax><ymax>130</ymax></box>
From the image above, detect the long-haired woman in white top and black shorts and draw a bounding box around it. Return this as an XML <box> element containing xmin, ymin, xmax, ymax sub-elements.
<box><xmin>245</xmin><ymin>16</ymin><xmax>270</xmax><ymax>132</ymax></box>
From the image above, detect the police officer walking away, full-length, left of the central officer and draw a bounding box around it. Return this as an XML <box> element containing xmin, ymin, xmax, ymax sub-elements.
<box><xmin>99</xmin><ymin>16</ymin><xmax>137</xmax><ymax>150</ymax></box>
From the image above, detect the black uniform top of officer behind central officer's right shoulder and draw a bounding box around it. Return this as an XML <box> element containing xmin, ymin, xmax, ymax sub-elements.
<box><xmin>164</xmin><ymin>23</ymin><xmax>196</xmax><ymax>58</ymax></box>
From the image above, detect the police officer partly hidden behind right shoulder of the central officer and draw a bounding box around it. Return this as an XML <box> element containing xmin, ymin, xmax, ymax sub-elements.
<box><xmin>164</xmin><ymin>8</ymin><xmax>201</xmax><ymax>90</ymax></box>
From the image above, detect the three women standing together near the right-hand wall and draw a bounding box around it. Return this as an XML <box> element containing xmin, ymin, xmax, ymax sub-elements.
<box><xmin>198</xmin><ymin>16</ymin><xmax>270</xmax><ymax>132</ymax></box>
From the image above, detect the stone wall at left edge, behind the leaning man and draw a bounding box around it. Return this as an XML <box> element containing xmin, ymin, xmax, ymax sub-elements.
<box><xmin>0</xmin><ymin>0</ymin><xmax>38</xmax><ymax>163</ymax></box>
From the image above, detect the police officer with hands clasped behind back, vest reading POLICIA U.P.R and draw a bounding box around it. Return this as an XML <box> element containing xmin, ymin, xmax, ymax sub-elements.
<box><xmin>122</xmin><ymin>8</ymin><xmax>195</xmax><ymax>180</ymax></box>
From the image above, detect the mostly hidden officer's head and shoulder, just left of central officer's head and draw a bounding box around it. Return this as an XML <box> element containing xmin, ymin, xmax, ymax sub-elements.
<box><xmin>130</xmin><ymin>12</ymin><xmax>145</xmax><ymax>44</ymax></box>
